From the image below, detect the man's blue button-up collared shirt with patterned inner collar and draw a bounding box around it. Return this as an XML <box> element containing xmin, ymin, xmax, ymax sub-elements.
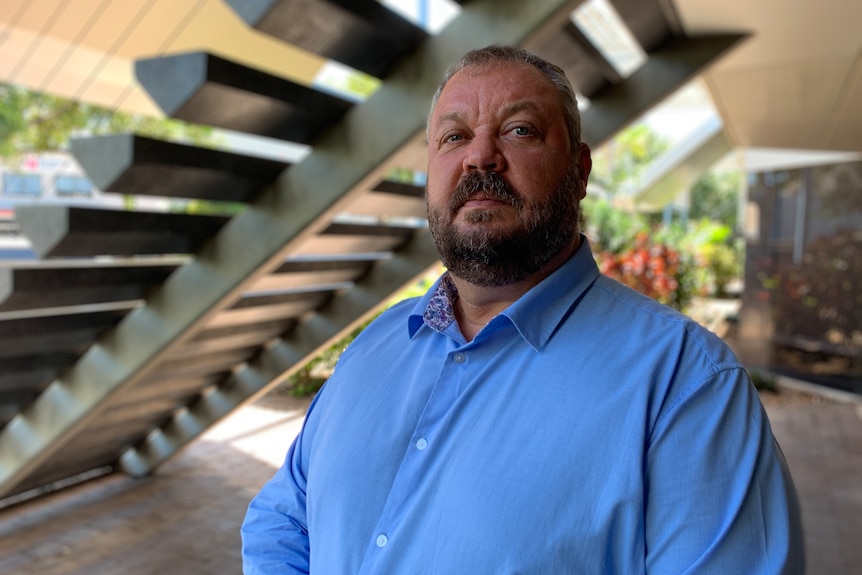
<box><xmin>242</xmin><ymin>237</ymin><xmax>803</xmax><ymax>575</ymax></box>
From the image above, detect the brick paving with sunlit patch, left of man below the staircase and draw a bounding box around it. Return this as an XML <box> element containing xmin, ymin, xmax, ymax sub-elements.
<box><xmin>0</xmin><ymin>396</ymin><xmax>308</xmax><ymax>575</ymax></box>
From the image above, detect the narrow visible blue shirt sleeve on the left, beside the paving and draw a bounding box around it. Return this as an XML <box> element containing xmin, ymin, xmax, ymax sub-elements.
<box><xmin>241</xmin><ymin>392</ymin><xmax>321</xmax><ymax>575</ymax></box>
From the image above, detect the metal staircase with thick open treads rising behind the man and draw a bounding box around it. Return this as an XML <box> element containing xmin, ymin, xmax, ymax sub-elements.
<box><xmin>0</xmin><ymin>0</ymin><xmax>743</xmax><ymax>497</ymax></box>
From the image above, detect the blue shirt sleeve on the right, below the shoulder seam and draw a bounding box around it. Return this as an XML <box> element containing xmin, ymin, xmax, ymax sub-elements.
<box><xmin>645</xmin><ymin>366</ymin><xmax>804</xmax><ymax>575</ymax></box>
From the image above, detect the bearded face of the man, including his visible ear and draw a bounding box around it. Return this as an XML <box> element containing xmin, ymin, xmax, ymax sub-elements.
<box><xmin>426</xmin><ymin>64</ymin><xmax>589</xmax><ymax>286</ymax></box>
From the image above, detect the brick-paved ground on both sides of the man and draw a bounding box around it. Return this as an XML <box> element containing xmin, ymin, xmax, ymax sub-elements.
<box><xmin>0</xmin><ymin>380</ymin><xmax>862</xmax><ymax>575</ymax></box>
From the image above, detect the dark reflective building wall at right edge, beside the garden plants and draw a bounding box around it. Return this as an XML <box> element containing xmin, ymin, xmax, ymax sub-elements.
<box><xmin>738</xmin><ymin>162</ymin><xmax>862</xmax><ymax>392</ymax></box>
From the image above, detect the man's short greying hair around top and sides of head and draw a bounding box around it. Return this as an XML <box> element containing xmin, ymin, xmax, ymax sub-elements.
<box><xmin>425</xmin><ymin>46</ymin><xmax>581</xmax><ymax>154</ymax></box>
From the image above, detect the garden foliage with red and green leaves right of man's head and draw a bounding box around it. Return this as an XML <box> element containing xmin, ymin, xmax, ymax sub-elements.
<box><xmin>581</xmin><ymin>124</ymin><xmax>742</xmax><ymax>309</ymax></box>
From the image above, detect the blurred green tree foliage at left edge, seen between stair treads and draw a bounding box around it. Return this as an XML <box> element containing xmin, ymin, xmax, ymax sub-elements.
<box><xmin>0</xmin><ymin>84</ymin><xmax>215</xmax><ymax>158</ymax></box>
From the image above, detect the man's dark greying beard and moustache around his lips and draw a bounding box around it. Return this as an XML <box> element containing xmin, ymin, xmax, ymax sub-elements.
<box><xmin>426</xmin><ymin>164</ymin><xmax>583</xmax><ymax>287</ymax></box>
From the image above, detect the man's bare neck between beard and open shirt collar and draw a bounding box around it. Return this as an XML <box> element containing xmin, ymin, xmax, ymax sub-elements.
<box><xmin>452</xmin><ymin>236</ymin><xmax>580</xmax><ymax>341</ymax></box>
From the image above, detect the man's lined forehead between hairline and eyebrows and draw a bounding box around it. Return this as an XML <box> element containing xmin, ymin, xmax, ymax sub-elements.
<box><xmin>432</xmin><ymin>62</ymin><xmax>562</xmax><ymax>125</ymax></box>
